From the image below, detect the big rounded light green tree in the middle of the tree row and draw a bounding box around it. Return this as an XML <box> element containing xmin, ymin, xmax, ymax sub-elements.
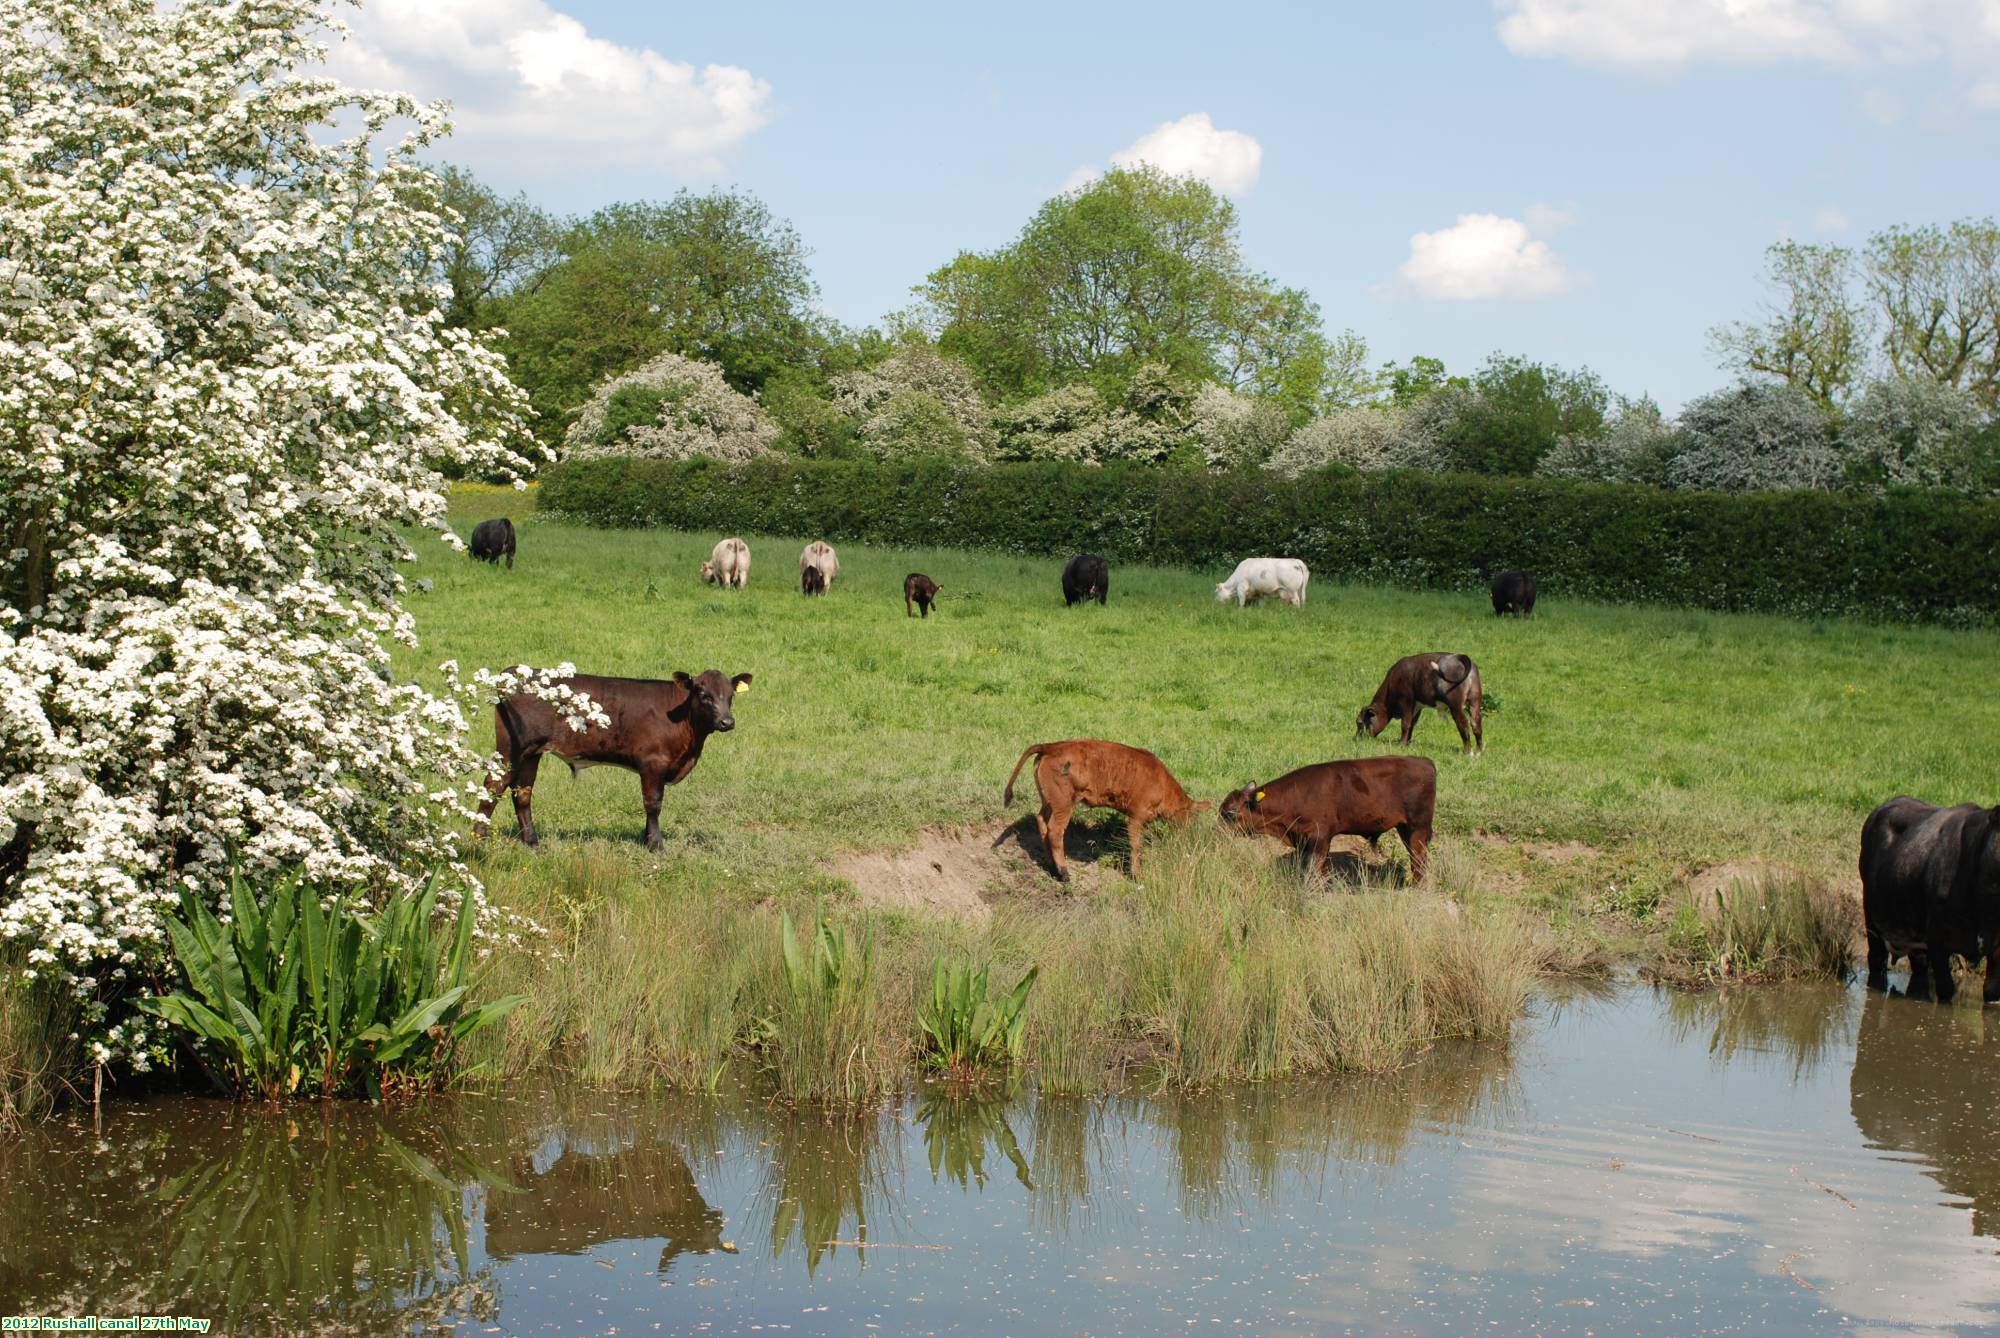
<box><xmin>918</xmin><ymin>166</ymin><xmax>1326</xmax><ymax>400</ymax></box>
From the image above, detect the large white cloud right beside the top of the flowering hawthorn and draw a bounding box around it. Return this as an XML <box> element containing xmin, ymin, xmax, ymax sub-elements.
<box><xmin>328</xmin><ymin>0</ymin><xmax>772</xmax><ymax>172</ymax></box>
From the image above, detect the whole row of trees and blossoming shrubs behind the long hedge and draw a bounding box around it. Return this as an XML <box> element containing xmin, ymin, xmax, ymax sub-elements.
<box><xmin>442</xmin><ymin>166</ymin><xmax>2000</xmax><ymax>492</ymax></box>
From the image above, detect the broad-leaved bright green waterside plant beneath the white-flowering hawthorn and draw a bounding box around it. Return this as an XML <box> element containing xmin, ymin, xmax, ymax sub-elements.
<box><xmin>140</xmin><ymin>872</ymin><xmax>520</xmax><ymax>1100</ymax></box>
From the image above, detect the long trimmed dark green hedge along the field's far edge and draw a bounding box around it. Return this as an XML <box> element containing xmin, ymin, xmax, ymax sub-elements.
<box><xmin>540</xmin><ymin>456</ymin><xmax>2000</xmax><ymax>624</ymax></box>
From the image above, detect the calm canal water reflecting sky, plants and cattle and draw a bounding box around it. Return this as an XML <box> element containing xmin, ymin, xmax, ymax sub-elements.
<box><xmin>0</xmin><ymin>986</ymin><xmax>2000</xmax><ymax>1334</ymax></box>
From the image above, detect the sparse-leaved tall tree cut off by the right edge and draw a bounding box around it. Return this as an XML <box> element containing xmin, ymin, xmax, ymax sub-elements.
<box><xmin>1864</xmin><ymin>218</ymin><xmax>2000</xmax><ymax>412</ymax></box>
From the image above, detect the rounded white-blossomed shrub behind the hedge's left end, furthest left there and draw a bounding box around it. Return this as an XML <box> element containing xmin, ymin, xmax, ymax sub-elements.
<box><xmin>562</xmin><ymin>354</ymin><xmax>778</xmax><ymax>460</ymax></box>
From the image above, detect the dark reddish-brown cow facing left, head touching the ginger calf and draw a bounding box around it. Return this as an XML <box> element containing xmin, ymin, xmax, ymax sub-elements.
<box><xmin>1222</xmin><ymin>758</ymin><xmax>1438</xmax><ymax>882</ymax></box>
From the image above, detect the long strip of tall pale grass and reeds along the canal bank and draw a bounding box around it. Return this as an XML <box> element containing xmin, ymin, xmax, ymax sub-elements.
<box><xmin>476</xmin><ymin>826</ymin><xmax>1546</xmax><ymax>1104</ymax></box>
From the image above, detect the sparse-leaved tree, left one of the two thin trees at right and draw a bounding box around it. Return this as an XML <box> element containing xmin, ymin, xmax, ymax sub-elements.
<box><xmin>1708</xmin><ymin>242</ymin><xmax>1868</xmax><ymax>410</ymax></box>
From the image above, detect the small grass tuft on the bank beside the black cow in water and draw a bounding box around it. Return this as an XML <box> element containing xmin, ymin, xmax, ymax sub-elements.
<box><xmin>1666</xmin><ymin>870</ymin><xmax>1862</xmax><ymax>980</ymax></box>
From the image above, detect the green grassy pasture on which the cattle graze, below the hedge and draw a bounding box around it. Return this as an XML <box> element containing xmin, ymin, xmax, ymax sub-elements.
<box><xmin>390</xmin><ymin>490</ymin><xmax>2000</xmax><ymax>1086</ymax></box>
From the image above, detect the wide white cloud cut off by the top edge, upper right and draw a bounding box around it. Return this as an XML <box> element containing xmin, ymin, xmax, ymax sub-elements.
<box><xmin>1496</xmin><ymin>0</ymin><xmax>2000</xmax><ymax>68</ymax></box>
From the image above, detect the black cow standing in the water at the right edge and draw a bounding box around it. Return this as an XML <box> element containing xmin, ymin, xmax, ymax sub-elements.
<box><xmin>1862</xmin><ymin>796</ymin><xmax>2000</xmax><ymax>1004</ymax></box>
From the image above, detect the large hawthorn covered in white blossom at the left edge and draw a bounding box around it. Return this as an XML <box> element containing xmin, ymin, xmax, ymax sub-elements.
<box><xmin>0</xmin><ymin>0</ymin><xmax>530</xmax><ymax>1064</ymax></box>
